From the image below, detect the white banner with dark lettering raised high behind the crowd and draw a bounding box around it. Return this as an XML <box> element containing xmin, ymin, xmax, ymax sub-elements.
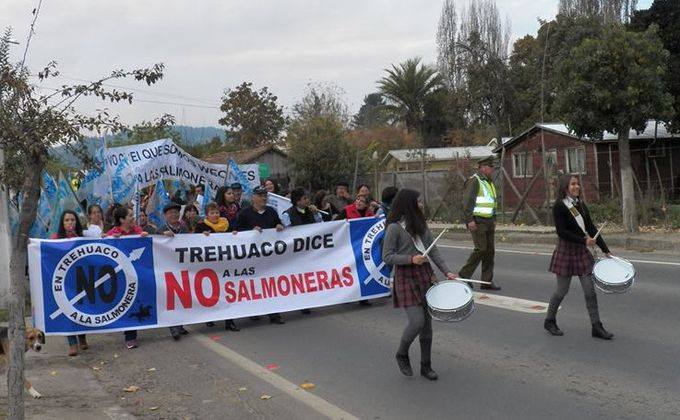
<box><xmin>100</xmin><ymin>139</ymin><xmax>260</xmax><ymax>190</ymax></box>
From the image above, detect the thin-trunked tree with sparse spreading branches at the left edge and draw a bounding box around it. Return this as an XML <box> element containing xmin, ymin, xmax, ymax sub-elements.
<box><xmin>0</xmin><ymin>26</ymin><xmax>163</xmax><ymax>419</ymax></box>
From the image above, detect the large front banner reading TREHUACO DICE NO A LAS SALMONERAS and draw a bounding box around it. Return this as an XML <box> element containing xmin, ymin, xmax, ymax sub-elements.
<box><xmin>28</xmin><ymin>218</ymin><xmax>389</xmax><ymax>335</ymax></box>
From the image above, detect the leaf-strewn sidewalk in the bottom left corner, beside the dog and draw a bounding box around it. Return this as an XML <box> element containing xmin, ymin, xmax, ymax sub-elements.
<box><xmin>0</xmin><ymin>330</ymin><xmax>135</xmax><ymax>420</ymax></box>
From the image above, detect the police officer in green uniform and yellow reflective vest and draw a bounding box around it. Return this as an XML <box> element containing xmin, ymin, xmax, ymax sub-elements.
<box><xmin>459</xmin><ymin>156</ymin><xmax>501</xmax><ymax>290</ymax></box>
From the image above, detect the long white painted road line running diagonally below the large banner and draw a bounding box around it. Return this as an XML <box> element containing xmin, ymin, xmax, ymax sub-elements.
<box><xmin>190</xmin><ymin>330</ymin><xmax>357</xmax><ymax>419</ymax></box>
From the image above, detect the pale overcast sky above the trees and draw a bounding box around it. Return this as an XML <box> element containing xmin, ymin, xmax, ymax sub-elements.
<box><xmin>0</xmin><ymin>0</ymin><xmax>651</xmax><ymax>126</ymax></box>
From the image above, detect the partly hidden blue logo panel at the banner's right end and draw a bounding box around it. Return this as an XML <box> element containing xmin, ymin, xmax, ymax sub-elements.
<box><xmin>350</xmin><ymin>218</ymin><xmax>391</xmax><ymax>296</ymax></box>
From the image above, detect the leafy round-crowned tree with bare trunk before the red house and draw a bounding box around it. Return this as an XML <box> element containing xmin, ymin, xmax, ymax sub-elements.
<box><xmin>555</xmin><ymin>25</ymin><xmax>673</xmax><ymax>232</ymax></box>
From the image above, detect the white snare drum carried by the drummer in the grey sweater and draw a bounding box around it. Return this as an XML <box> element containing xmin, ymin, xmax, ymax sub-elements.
<box><xmin>425</xmin><ymin>280</ymin><xmax>475</xmax><ymax>322</ymax></box>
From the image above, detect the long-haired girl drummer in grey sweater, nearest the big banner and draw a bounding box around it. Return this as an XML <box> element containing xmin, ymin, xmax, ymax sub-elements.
<box><xmin>383</xmin><ymin>189</ymin><xmax>456</xmax><ymax>380</ymax></box>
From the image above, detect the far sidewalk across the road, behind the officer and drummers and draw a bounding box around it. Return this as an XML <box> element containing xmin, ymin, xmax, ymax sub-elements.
<box><xmin>429</xmin><ymin>222</ymin><xmax>680</xmax><ymax>254</ymax></box>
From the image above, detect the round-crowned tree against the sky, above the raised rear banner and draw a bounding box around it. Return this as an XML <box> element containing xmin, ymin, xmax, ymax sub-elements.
<box><xmin>219</xmin><ymin>82</ymin><xmax>286</xmax><ymax>147</ymax></box>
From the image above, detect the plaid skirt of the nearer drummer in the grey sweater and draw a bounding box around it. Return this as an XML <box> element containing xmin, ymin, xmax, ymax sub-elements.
<box><xmin>392</xmin><ymin>263</ymin><xmax>435</xmax><ymax>308</ymax></box>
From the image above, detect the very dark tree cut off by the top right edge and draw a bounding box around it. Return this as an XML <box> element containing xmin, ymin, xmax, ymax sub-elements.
<box><xmin>630</xmin><ymin>0</ymin><xmax>680</xmax><ymax>132</ymax></box>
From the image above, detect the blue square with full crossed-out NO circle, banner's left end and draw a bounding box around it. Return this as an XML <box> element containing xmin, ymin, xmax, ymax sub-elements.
<box><xmin>42</xmin><ymin>238</ymin><xmax>156</xmax><ymax>332</ymax></box>
